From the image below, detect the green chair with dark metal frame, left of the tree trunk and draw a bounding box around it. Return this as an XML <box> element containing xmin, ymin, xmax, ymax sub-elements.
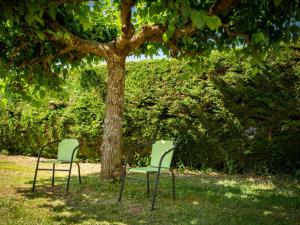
<box><xmin>32</xmin><ymin>139</ymin><xmax>81</xmax><ymax>193</ymax></box>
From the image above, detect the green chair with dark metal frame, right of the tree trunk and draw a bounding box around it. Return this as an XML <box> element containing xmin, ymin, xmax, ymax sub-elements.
<box><xmin>118</xmin><ymin>140</ymin><xmax>175</xmax><ymax>210</ymax></box>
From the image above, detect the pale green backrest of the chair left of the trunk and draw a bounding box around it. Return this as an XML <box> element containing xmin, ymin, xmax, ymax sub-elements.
<box><xmin>57</xmin><ymin>139</ymin><xmax>79</xmax><ymax>161</ymax></box>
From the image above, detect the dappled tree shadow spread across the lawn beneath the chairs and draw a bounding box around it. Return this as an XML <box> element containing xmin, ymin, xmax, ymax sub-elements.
<box><xmin>18</xmin><ymin>171</ymin><xmax>300</xmax><ymax>225</ymax></box>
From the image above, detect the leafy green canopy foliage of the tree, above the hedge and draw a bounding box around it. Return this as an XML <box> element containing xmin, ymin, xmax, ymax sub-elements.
<box><xmin>0</xmin><ymin>0</ymin><xmax>300</xmax><ymax>95</ymax></box>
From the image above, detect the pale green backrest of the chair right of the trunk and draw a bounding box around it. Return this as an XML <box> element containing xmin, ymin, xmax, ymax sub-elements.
<box><xmin>150</xmin><ymin>140</ymin><xmax>174</xmax><ymax>168</ymax></box>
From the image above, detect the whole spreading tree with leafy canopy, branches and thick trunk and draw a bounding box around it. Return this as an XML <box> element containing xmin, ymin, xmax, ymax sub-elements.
<box><xmin>0</xmin><ymin>0</ymin><xmax>299</xmax><ymax>178</ymax></box>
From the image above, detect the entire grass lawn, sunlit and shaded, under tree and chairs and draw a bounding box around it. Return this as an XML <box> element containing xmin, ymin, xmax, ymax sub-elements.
<box><xmin>0</xmin><ymin>155</ymin><xmax>300</xmax><ymax>225</ymax></box>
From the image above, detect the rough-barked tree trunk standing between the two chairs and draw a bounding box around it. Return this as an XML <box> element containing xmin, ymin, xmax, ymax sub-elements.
<box><xmin>101</xmin><ymin>54</ymin><xmax>126</xmax><ymax>179</ymax></box>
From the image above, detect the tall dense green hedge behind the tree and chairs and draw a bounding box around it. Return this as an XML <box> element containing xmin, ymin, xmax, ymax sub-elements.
<box><xmin>0</xmin><ymin>51</ymin><xmax>300</xmax><ymax>173</ymax></box>
